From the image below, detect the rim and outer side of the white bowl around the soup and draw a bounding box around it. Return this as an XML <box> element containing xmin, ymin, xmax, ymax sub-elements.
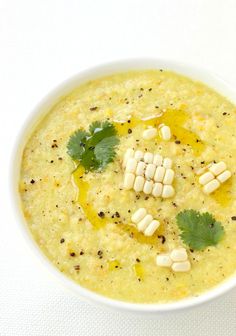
<box><xmin>11</xmin><ymin>59</ymin><xmax>236</xmax><ymax>314</ymax></box>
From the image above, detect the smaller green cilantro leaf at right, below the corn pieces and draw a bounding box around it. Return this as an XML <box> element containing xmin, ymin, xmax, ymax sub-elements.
<box><xmin>176</xmin><ymin>210</ymin><xmax>224</xmax><ymax>250</ymax></box>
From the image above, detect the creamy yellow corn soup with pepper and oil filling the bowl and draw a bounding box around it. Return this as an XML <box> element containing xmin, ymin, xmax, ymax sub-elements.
<box><xmin>19</xmin><ymin>70</ymin><xmax>236</xmax><ymax>303</ymax></box>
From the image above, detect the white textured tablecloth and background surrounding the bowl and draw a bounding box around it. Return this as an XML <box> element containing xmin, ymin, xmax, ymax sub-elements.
<box><xmin>0</xmin><ymin>0</ymin><xmax>236</xmax><ymax>336</ymax></box>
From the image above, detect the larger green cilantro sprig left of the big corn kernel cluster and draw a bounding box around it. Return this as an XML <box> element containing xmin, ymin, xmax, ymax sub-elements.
<box><xmin>67</xmin><ymin>121</ymin><xmax>119</xmax><ymax>171</ymax></box>
